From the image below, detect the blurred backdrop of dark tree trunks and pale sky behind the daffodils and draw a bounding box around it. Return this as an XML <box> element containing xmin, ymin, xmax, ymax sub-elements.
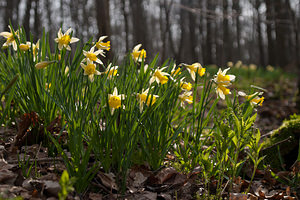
<box><xmin>0</xmin><ymin>0</ymin><xmax>300</xmax><ymax>69</ymax></box>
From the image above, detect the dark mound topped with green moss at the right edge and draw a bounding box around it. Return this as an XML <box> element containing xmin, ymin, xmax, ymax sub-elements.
<box><xmin>262</xmin><ymin>115</ymin><xmax>300</xmax><ymax>169</ymax></box>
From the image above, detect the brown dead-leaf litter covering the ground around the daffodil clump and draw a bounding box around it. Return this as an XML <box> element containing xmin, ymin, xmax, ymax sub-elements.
<box><xmin>0</xmin><ymin>76</ymin><xmax>300</xmax><ymax>200</ymax></box>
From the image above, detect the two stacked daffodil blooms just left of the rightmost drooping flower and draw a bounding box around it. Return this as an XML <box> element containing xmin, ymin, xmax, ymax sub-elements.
<box><xmin>214</xmin><ymin>68</ymin><xmax>235</xmax><ymax>100</ymax></box>
